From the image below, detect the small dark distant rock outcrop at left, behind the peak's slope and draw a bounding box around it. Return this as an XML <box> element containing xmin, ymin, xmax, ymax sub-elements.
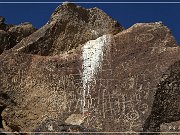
<box><xmin>0</xmin><ymin>17</ymin><xmax>36</xmax><ymax>54</ymax></box>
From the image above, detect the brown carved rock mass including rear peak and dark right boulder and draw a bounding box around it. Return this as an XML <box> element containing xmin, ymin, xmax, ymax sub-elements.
<box><xmin>0</xmin><ymin>3</ymin><xmax>180</xmax><ymax>134</ymax></box>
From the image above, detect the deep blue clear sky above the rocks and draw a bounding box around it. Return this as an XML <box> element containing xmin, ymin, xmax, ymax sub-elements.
<box><xmin>0</xmin><ymin>0</ymin><xmax>180</xmax><ymax>43</ymax></box>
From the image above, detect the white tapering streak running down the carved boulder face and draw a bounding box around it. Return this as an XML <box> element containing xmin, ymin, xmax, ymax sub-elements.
<box><xmin>82</xmin><ymin>35</ymin><xmax>109</xmax><ymax>113</ymax></box>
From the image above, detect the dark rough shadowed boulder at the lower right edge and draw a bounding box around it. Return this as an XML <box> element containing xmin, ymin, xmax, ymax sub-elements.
<box><xmin>144</xmin><ymin>61</ymin><xmax>180</xmax><ymax>132</ymax></box>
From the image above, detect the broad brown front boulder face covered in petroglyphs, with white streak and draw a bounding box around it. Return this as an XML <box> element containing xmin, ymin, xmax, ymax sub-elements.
<box><xmin>0</xmin><ymin>16</ymin><xmax>179</xmax><ymax>132</ymax></box>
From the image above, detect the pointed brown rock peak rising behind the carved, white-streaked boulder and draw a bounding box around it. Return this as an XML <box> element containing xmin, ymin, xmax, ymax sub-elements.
<box><xmin>11</xmin><ymin>3</ymin><xmax>124</xmax><ymax>56</ymax></box>
